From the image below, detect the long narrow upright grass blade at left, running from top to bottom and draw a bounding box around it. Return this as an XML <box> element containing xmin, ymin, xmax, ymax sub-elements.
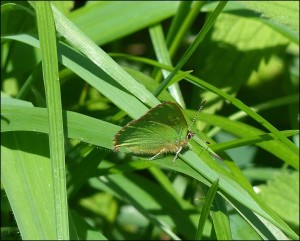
<box><xmin>35</xmin><ymin>2</ymin><xmax>69</xmax><ymax>240</ymax></box>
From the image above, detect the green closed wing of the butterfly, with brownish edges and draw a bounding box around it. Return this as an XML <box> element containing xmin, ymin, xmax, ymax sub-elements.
<box><xmin>114</xmin><ymin>101</ymin><xmax>188</xmax><ymax>154</ymax></box>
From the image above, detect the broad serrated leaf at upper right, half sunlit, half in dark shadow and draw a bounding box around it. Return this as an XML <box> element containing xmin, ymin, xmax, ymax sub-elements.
<box><xmin>191</xmin><ymin>14</ymin><xmax>289</xmax><ymax>113</ymax></box>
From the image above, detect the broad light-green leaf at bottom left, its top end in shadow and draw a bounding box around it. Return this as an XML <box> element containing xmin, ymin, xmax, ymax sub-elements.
<box><xmin>1</xmin><ymin>132</ymin><xmax>56</xmax><ymax>240</ymax></box>
